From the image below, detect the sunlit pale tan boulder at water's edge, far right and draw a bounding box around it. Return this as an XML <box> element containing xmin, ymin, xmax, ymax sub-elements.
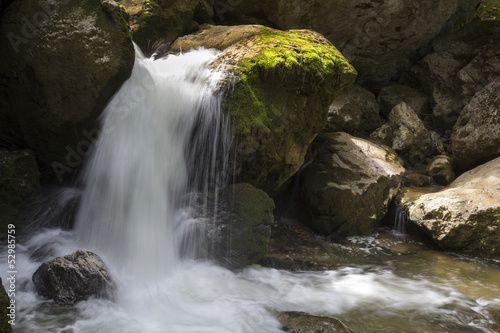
<box><xmin>408</xmin><ymin>157</ymin><xmax>500</xmax><ymax>258</ymax></box>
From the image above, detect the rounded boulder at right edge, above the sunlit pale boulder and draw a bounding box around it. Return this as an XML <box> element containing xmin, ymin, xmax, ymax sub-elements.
<box><xmin>451</xmin><ymin>76</ymin><xmax>500</xmax><ymax>170</ymax></box>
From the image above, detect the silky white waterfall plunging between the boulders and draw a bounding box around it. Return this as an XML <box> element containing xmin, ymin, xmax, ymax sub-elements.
<box><xmin>76</xmin><ymin>43</ymin><xmax>229</xmax><ymax>278</ymax></box>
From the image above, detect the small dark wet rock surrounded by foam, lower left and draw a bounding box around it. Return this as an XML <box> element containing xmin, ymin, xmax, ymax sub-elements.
<box><xmin>33</xmin><ymin>250</ymin><xmax>115</xmax><ymax>305</ymax></box>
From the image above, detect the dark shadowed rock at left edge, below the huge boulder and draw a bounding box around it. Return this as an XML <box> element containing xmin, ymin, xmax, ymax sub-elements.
<box><xmin>0</xmin><ymin>148</ymin><xmax>40</xmax><ymax>235</ymax></box>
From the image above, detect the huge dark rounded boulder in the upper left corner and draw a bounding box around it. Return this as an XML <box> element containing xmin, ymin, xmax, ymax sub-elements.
<box><xmin>0</xmin><ymin>0</ymin><xmax>134</xmax><ymax>178</ymax></box>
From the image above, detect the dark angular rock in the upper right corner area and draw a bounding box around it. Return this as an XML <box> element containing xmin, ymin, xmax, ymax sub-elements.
<box><xmin>412</xmin><ymin>20</ymin><xmax>500</xmax><ymax>129</ymax></box>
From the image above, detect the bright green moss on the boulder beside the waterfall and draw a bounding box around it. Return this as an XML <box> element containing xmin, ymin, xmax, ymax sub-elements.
<box><xmin>225</xmin><ymin>27</ymin><xmax>357</xmax><ymax>134</ymax></box>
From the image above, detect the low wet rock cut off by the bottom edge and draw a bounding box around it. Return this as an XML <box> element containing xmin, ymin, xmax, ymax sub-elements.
<box><xmin>276</xmin><ymin>311</ymin><xmax>351</xmax><ymax>333</ymax></box>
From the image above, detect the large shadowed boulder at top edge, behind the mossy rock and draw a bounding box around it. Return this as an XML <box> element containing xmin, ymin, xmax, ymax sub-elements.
<box><xmin>214</xmin><ymin>0</ymin><xmax>479</xmax><ymax>87</ymax></box>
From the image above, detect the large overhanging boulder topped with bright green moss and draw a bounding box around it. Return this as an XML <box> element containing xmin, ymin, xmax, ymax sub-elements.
<box><xmin>172</xmin><ymin>26</ymin><xmax>356</xmax><ymax>194</ymax></box>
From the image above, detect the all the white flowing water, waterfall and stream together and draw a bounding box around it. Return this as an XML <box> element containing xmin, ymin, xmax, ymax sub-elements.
<box><xmin>0</xmin><ymin>49</ymin><xmax>500</xmax><ymax>333</ymax></box>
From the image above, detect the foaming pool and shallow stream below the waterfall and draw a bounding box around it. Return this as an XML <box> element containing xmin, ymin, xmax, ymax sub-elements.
<box><xmin>0</xmin><ymin>224</ymin><xmax>500</xmax><ymax>333</ymax></box>
